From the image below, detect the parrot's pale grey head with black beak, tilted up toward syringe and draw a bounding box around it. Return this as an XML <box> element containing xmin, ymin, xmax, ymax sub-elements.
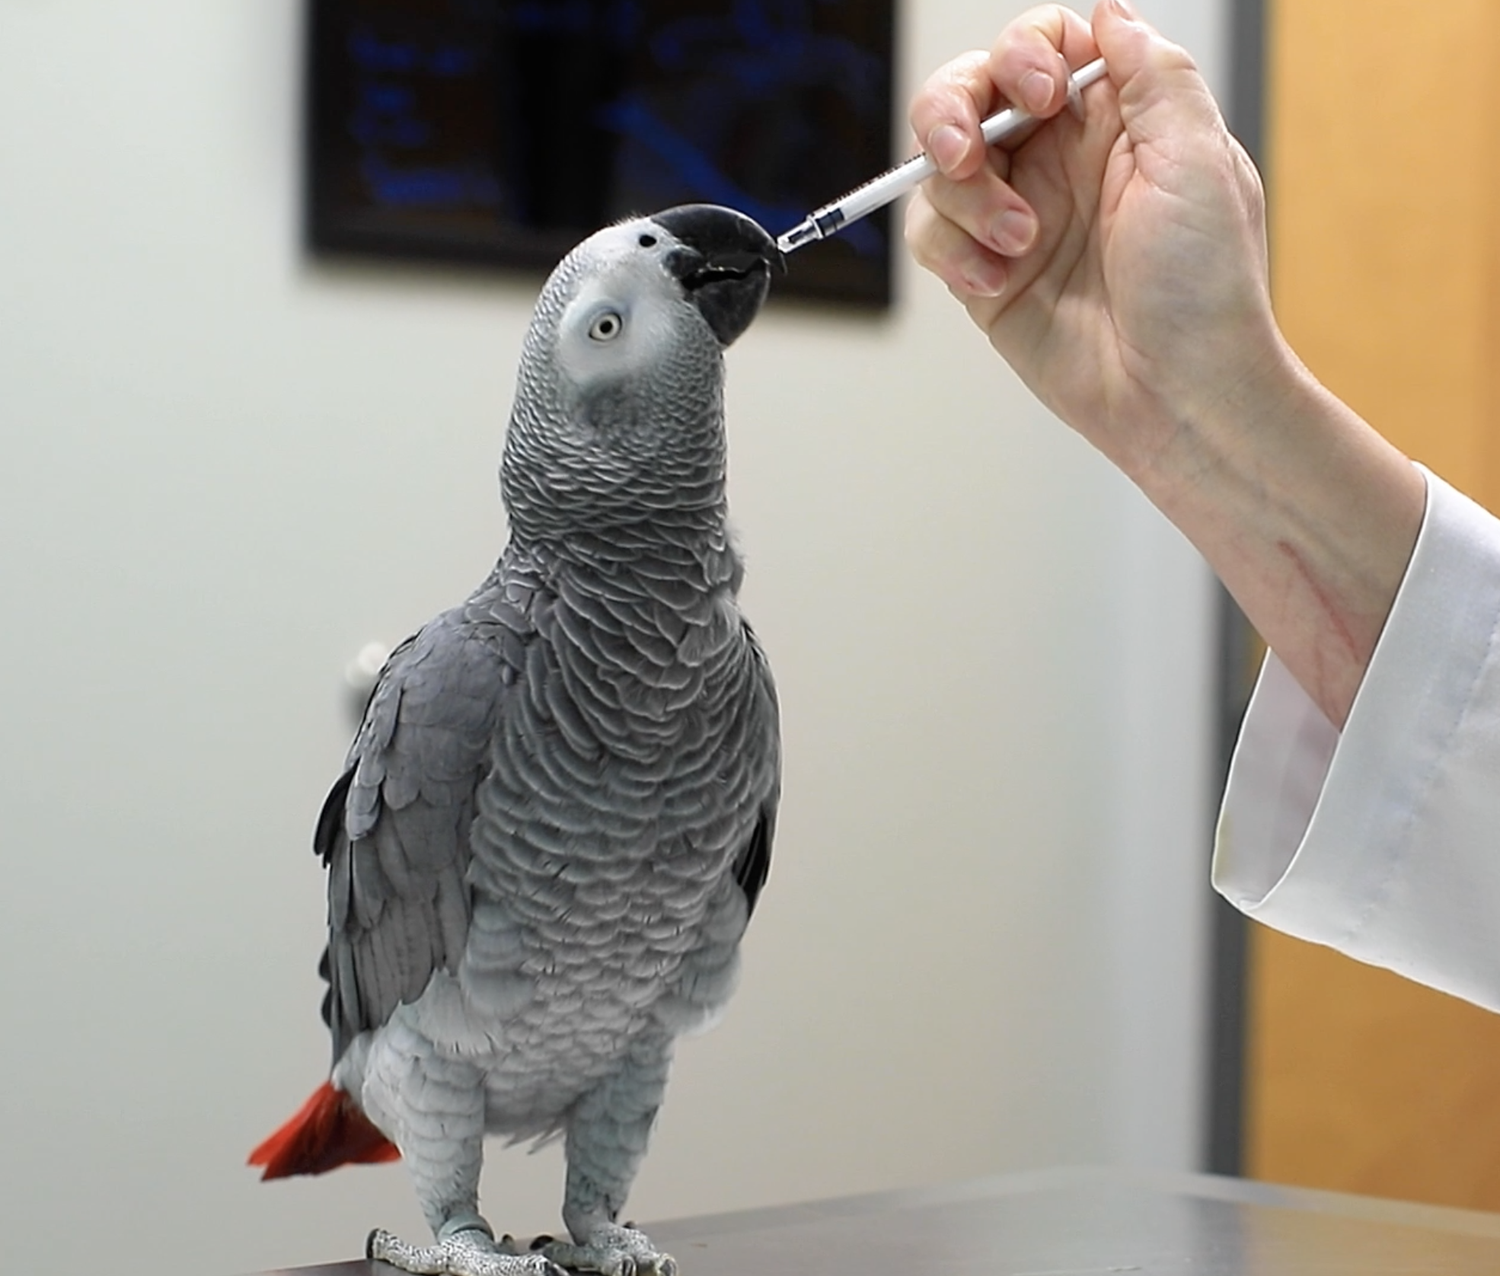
<box><xmin>501</xmin><ymin>204</ymin><xmax>782</xmax><ymax>537</ymax></box>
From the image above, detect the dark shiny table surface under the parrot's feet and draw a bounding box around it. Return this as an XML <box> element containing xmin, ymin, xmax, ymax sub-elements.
<box><xmin>249</xmin><ymin>1170</ymin><xmax>1500</xmax><ymax>1276</ymax></box>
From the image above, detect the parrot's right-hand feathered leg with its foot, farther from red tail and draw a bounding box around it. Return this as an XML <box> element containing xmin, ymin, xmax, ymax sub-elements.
<box><xmin>542</xmin><ymin>1035</ymin><xmax>677</xmax><ymax>1276</ymax></box>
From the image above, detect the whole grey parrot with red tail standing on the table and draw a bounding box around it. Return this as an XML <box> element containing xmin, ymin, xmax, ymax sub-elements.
<box><xmin>251</xmin><ymin>204</ymin><xmax>780</xmax><ymax>1276</ymax></box>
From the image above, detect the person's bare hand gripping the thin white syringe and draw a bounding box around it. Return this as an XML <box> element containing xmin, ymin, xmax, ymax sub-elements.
<box><xmin>906</xmin><ymin>0</ymin><xmax>1292</xmax><ymax>481</ymax></box>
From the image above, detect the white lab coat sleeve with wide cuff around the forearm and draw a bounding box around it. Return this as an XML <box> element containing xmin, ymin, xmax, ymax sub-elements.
<box><xmin>1214</xmin><ymin>471</ymin><xmax>1500</xmax><ymax>1009</ymax></box>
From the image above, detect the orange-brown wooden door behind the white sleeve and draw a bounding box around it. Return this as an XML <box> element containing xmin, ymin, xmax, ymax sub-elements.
<box><xmin>1245</xmin><ymin>0</ymin><xmax>1500</xmax><ymax>1210</ymax></box>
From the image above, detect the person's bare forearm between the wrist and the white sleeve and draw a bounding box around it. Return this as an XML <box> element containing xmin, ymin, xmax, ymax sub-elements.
<box><xmin>1133</xmin><ymin>340</ymin><xmax>1425</xmax><ymax>727</ymax></box>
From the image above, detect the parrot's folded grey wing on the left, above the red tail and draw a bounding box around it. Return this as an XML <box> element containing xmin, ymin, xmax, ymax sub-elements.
<box><xmin>314</xmin><ymin>603</ymin><xmax>525</xmax><ymax>1062</ymax></box>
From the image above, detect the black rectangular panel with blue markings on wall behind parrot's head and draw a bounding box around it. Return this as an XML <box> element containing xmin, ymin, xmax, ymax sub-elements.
<box><xmin>305</xmin><ymin>0</ymin><xmax>894</xmax><ymax>307</ymax></box>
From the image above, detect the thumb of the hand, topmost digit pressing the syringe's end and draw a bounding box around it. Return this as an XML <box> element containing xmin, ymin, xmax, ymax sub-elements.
<box><xmin>1092</xmin><ymin>0</ymin><xmax>1223</xmax><ymax>141</ymax></box>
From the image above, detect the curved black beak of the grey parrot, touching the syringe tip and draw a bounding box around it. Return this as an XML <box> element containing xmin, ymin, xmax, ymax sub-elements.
<box><xmin>651</xmin><ymin>204</ymin><xmax>786</xmax><ymax>346</ymax></box>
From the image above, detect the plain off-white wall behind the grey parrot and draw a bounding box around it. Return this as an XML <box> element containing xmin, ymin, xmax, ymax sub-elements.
<box><xmin>0</xmin><ymin>0</ymin><xmax>1223</xmax><ymax>1276</ymax></box>
